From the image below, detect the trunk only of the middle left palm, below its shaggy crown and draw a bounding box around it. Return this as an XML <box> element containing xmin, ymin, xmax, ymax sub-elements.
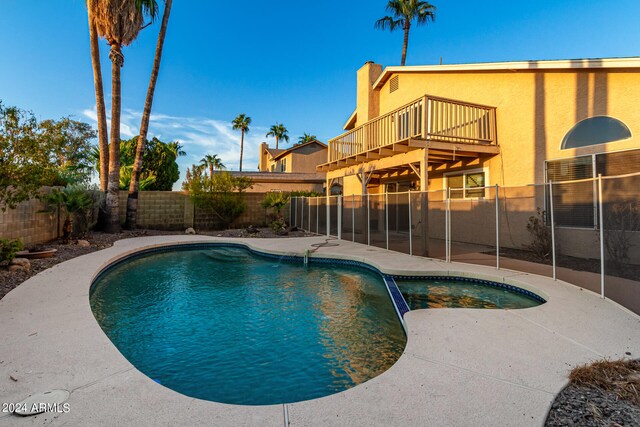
<box><xmin>106</xmin><ymin>42</ymin><xmax>124</xmax><ymax>233</ymax></box>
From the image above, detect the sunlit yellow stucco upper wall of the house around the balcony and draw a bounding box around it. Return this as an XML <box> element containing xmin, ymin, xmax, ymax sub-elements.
<box><xmin>376</xmin><ymin>70</ymin><xmax>640</xmax><ymax>188</ymax></box>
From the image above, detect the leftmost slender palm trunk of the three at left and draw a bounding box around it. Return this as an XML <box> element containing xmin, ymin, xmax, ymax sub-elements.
<box><xmin>88</xmin><ymin>9</ymin><xmax>109</xmax><ymax>192</ymax></box>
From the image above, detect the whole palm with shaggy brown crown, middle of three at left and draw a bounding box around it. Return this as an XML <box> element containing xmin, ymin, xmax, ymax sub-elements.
<box><xmin>87</xmin><ymin>0</ymin><xmax>157</xmax><ymax>233</ymax></box>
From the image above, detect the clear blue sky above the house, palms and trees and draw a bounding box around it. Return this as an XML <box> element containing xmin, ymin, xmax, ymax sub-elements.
<box><xmin>0</xmin><ymin>0</ymin><xmax>640</xmax><ymax>186</ymax></box>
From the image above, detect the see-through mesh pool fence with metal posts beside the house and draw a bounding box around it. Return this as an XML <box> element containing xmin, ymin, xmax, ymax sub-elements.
<box><xmin>285</xmin><ymin>173</ymin><xmax>640</xmax><ymax>314</ymax></box>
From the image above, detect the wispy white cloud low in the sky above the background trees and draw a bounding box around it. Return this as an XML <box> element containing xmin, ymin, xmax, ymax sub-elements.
<box><xmin>82</xmin><ymin>107</ymin><xmax>268</xmax><ymax>189</ymax></box>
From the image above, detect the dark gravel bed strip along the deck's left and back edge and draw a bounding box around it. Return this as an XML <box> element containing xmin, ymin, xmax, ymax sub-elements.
<box><xmin>0</xmin><ymin>228</ymin><xmax>313</xmax><ymax>299</ymax></box>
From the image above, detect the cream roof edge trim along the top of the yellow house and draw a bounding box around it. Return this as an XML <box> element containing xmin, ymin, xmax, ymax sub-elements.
<box><xmin>372</xmin><ymin>56</ymin><xmax>640</xmax><ymax>89</ymax></box>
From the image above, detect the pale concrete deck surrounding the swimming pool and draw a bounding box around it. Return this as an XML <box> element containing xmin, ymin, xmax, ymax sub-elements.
<box><xmin>0</xmin><ymin>236</ymin><xmax>640</xmax><ymax>427</ymax></box>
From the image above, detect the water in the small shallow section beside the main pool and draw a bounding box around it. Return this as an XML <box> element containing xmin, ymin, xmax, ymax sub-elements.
<box><xmin>396</xmin><ymin>279</ymin><xmax>542</xmax><ymax>310</ymax></box>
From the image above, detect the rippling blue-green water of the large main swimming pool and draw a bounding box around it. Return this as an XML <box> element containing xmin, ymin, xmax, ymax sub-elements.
<box><xmin>90</xmin><ymin>247</ymin><xmax>406</xmax><ymax>405</ymax></box>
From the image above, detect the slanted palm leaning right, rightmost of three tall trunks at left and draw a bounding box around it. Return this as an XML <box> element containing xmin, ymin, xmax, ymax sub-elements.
<box><xmin>125</xmin><ymin>0</ymin><xmax>172</xmax><ymax>230</ymax></box>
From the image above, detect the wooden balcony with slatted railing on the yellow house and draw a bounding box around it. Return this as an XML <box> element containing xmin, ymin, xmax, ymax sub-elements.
<box><xmin>318</xmin><ymin>95</ymin><xmax>499</xmax><ymax>171</ymax></box>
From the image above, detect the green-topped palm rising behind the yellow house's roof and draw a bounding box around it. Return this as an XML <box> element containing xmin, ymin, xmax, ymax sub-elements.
<box><xmin>375</xmin><ymin>0</ymin><xmax>436</xmax><ymax>66</ymax></box>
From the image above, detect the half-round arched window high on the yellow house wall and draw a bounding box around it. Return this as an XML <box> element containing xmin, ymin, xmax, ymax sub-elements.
<box><xmin>560</xmin><ymin>116</ymin><xmax>631</xmax><ymax>150</ymax></box>
